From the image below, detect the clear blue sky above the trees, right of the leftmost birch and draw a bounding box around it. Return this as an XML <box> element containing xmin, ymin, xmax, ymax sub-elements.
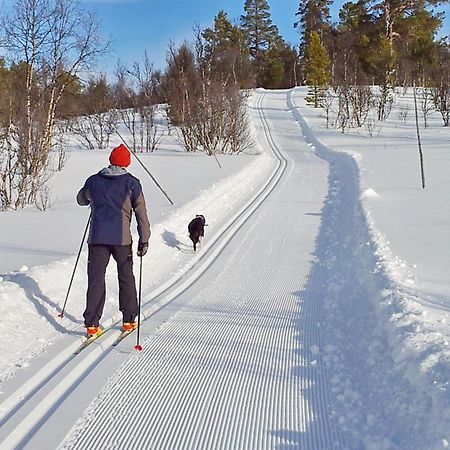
<box><xmin>83</xmin><ymin>0</ymin><xmax>299</xmax><ymax>76</ymax></box>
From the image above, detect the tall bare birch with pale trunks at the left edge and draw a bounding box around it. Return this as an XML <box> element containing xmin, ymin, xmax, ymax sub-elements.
<box><xmin>1</xmin><ymin>0</ymin><xmax>107</xmax><ymax>208</ymax></box>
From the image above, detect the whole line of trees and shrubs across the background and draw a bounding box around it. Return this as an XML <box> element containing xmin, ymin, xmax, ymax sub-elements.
<box><xmin>0</xmin><ymin>0</ymin><xmax>450</xmax><ymax>209</ymax></box>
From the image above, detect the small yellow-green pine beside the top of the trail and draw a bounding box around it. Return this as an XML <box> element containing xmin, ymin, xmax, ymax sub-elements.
<box><xmin>305</xmin><ymin>31</ymin><xmax>331</xmax><ymax>108</ymax></box>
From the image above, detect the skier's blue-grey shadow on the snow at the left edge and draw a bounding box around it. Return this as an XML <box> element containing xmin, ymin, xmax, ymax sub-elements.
<box><xmin>3</xmin><ymin>273</ymin><xmax>82</xmax><ymax>333</ymax></box>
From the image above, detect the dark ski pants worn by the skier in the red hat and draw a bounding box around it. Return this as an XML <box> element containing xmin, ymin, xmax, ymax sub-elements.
<box><xmin>83</xmin><ymin>245</ymin><xmax>138</xmax><ymax>326</ymax></box>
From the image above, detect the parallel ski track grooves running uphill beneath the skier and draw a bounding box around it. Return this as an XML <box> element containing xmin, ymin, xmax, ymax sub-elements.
<box><xmin>0</xmin><ymin>93</ymin><xmax>287</xmax><ymax>450</ymax></box>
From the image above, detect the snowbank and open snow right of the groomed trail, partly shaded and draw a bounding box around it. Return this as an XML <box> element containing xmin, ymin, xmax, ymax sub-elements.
<box><xmin>288</xmin><ymin>88</ymin><xmax>450</xmax><ymax>449</ymax></box>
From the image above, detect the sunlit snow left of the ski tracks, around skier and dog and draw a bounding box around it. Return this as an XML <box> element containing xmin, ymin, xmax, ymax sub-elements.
<box><xmin>0</xmin><ymin>133</ymin><xmax>274</xmax><ymax>381</ymax></box>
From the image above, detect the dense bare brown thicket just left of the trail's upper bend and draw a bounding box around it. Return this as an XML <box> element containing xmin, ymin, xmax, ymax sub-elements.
<box><xmin>163</xmin><ymin>30</ymin><xmax>250</xmax><ymax>155</ymax></box>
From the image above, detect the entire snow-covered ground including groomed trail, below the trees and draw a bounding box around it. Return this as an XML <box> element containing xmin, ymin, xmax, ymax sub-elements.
<box><xmin>0</xmin><ymin>88</ymin><xmax>450</xmax><ymax>450</ymax></box>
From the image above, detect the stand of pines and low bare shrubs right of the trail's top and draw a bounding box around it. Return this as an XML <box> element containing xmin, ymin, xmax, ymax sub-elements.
<box><xmin>295</xmin><ymin>0</ymin><xmax>450</xmax><ymax>131</ymax></box>
